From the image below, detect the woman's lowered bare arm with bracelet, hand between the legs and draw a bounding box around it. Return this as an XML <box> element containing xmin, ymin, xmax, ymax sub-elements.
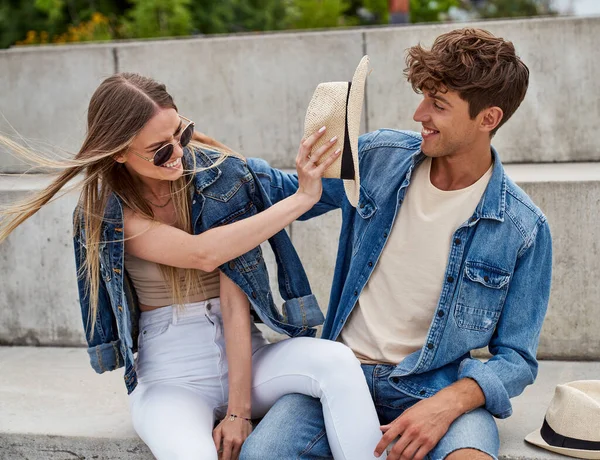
<box><xmin>213</xmin><ymin>273</ymin><xmax>252</xmax><ymax>460</ymax></box>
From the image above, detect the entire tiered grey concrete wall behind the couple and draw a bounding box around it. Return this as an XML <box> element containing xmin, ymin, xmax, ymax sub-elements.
<box><xmin>0</xmin><ymin>18</ymin><xmax>600</xmax><ymax>359</ymax></box>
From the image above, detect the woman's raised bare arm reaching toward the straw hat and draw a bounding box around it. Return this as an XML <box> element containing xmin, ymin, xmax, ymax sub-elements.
<box><xmin>125</xmin><ymin>126</ymin><xmax>340</xmax><ymax>272</ymax></box>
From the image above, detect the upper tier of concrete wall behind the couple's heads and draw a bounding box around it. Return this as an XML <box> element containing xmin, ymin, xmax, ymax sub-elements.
<box><xmin>0</xmin><ymin>18</ymin><xmax>600</xmax><ymax>172</ymax></box>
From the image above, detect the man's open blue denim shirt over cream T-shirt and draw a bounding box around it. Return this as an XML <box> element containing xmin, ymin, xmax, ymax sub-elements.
<box><xmin>249</xmin><ymin>130</ymin><xmax>552</xmax><ymax>418</ymax></box>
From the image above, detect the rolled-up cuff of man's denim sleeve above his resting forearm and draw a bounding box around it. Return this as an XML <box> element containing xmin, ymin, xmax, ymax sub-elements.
<box><xmin>458</xmin><ymin>358</ymin><xmax>512</xmax><ymax>418</ymax></box>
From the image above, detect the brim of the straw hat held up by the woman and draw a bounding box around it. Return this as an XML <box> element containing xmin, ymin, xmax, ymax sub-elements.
<box><xmin>344</xmin><ymin>56</ymin><xmax>369</xmax><ymax>207</ymax></box>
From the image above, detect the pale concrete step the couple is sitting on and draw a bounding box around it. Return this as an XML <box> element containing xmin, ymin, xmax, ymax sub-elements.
<box><xmin>0</xmin><ymin>347</ymin><xmax>600</xmax><ymax>460</ymax></box>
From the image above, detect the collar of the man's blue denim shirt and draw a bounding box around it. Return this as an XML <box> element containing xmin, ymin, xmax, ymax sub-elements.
<box><xmin>407</xmin><ymin>147</ymin><xmax>506</xmax><ymax>225</ymax></box>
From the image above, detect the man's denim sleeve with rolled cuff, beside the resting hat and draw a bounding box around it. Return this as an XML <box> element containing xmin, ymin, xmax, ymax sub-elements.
<box><xmin>458</xmin><ymin>217</ymin><xmax>552</xmax><ymax>418</ymax></box>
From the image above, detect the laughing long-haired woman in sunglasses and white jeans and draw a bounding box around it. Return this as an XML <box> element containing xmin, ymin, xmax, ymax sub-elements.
<box><xmin>0</xmin><ymin>73</ymin><xmax>381</xmax><ymax>460</ymax></box>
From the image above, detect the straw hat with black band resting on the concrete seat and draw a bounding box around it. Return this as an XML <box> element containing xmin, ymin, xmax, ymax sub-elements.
<box><xmin>525</xmin><ymin>380</ymin><xmax>600</xmax><ymax>459</ymax></box>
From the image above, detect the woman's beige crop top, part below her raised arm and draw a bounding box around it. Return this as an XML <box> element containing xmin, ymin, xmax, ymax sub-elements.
<box><xmin>125</xmin><ymin>252</ymin><xmax>219</xmax><ymax>307</ymax></box>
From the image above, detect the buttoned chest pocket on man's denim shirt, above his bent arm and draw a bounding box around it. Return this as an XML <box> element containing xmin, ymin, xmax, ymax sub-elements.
<box><xmin>454</xmin><ymin>261</ymin><xmax>510</xmax><ymax>332</ymax></box>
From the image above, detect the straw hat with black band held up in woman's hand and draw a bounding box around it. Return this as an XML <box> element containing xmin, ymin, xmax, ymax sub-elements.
<box><xmin>304</xmin><ymin>56</ymin><xmax>369</xmax><ymax>207</ymax></box>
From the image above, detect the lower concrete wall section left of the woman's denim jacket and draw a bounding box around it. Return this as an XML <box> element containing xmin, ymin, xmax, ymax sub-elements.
<box><xmin>0</xmin><ymin>177</ymin><xmax>83</xmax><ymax>345</ymax></box>
